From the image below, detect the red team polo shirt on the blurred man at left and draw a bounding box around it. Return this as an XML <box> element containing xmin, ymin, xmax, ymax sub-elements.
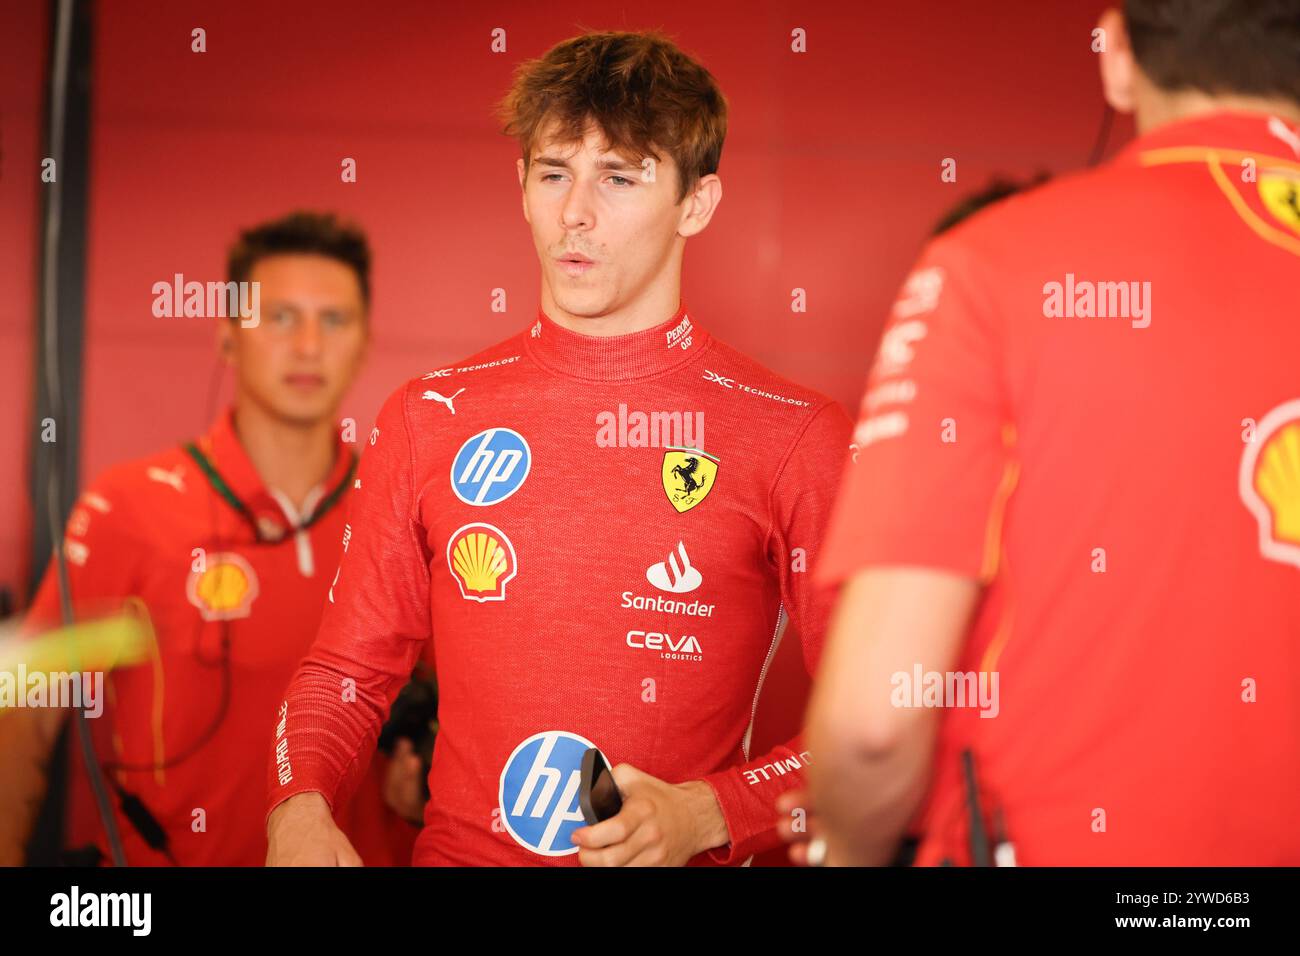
<box><xmin>27</xmin><ymin>410</ymin><xmax>410</xmax><ymax>866</ymax></box>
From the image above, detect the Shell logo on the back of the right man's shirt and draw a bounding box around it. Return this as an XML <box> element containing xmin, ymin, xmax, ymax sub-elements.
<box><xmin>1238</xmin><ymin>398</ymin><xmax>1300</xmax><ymax>567</ymax></box>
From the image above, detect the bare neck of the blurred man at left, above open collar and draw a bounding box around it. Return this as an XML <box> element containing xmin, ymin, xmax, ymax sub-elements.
<box><xmin>235</xmin><ymin>397</ymin><xmax>335</xmax><ymax>510</ymax></box>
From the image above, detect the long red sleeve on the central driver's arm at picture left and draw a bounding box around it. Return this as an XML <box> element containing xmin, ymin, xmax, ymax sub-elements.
<box><xmin>268</xmin><ymin>385</ymin><xmax>432</xmax><ymax>816</ymax></box>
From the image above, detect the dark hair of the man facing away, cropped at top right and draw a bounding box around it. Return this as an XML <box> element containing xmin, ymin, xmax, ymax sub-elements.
<box><xmin>1125</xmin><ymin>0</ymin><xmax>1300</xmax><ymax>103</ymax></box>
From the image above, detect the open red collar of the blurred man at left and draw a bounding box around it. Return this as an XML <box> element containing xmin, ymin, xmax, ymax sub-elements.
<box><xmin>189</xmin><ymin>406</ymin><xmax>352</xmax><ymax>541</ymax></box>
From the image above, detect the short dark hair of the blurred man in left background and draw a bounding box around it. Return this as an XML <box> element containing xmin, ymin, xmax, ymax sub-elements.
<box><xmin>226</xmin><ymin>211</ymin><xmax>371</xmax><ymax>310</ymax></box>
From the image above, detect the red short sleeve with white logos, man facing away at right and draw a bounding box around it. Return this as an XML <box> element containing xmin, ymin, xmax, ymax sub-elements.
<box><xmin>815</xmin><ymin>234</ymin><xmax>1015</xmax><ymax>584</ymax></box>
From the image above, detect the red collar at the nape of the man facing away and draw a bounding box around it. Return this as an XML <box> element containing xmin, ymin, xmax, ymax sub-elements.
<box><xmin>1115</xmin><ymin>111</ymin><xmax>1300</xmax><ymax>165</ymax></box>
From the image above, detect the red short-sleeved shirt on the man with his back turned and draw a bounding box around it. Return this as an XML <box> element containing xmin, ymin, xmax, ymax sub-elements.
<box><xmin>818</xmin><ymin>113</ymin><xmax>1300</xmax><ymax>865</ymax></box>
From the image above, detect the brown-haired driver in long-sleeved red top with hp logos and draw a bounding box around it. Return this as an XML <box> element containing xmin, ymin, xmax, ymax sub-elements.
<box><xmin>267</xmin><ymin>34</ymin><xmax>852</xmax><ymax>866</ymax></box>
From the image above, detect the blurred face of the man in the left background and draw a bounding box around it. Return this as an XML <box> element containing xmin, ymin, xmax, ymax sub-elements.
<box><xmin>221</xmin><ymin>254</ymin><xmax>369</xmax><ymax>424</ymax></box>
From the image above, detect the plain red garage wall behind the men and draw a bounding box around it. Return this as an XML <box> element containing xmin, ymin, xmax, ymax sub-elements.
<box><xmin>0</xmin><ymin>0</ymin><xmax>1130</xmax><ymax>868</ymax></box>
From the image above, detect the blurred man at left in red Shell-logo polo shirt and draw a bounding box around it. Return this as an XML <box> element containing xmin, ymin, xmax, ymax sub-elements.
<box><xmin>17</xmin><ymin>213</ymin><xmax>406</xmax><ymax>866</ymax></box>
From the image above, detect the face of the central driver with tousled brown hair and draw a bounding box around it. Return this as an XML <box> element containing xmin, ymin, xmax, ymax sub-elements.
<box><xmin>517</xmin><ymin>119</ymin><xmax>689</xmax><ymax>317</ymax></box>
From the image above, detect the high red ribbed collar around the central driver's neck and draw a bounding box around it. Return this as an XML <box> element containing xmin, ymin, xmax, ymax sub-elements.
<box><xmin>525</xmin><ymin>304</ymin><xmax>710</xmax><ymax>381</ymax></box>
